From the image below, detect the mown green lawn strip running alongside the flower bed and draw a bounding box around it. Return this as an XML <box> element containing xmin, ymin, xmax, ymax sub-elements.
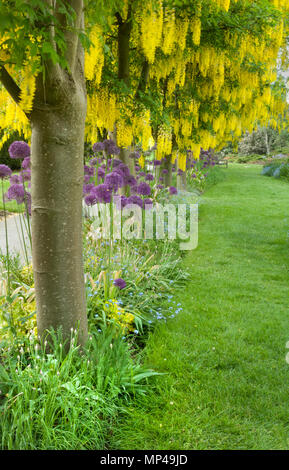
<box><xmin>109</xmin><ymin>165</ymin><xmax>289</xmax><ymax>450</ymax></box>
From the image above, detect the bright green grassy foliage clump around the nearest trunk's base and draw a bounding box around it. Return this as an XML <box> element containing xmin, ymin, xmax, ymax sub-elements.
<box><xmin>0</xmin><ymin>329</ymin><xmax>155</xmax><ymax>450</ymax></box>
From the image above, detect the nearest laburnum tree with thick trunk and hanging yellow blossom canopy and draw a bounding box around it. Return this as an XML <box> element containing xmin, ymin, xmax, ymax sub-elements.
<box><xmin>0</xmin><ymin>0</ymin><xmax>289</xmax><ymax>343</ymax></box>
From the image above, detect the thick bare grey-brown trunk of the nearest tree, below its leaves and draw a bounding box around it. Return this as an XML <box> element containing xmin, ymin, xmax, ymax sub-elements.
<box><xmin>31</xmin><ymin>81</ymin><xmax>87</xmax><ymax>344</ymax></box>
